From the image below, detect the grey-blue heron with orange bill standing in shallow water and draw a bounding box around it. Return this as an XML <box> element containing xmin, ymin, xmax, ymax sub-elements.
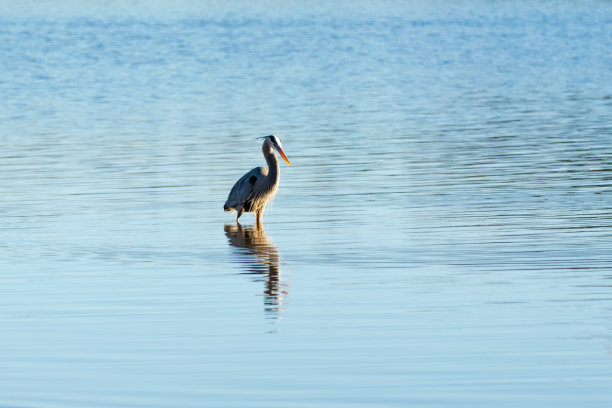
<box><xmin>223</xmin><ymin>135</ymin><xmax>291</xmax><ymax>225</ymax></box>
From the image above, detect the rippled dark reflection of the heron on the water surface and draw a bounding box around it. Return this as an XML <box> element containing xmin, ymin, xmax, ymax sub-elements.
<box><xmin>225</xmin><ymin>223</ymin><xmax>288</xmax><ymax>316</ymax></box>
